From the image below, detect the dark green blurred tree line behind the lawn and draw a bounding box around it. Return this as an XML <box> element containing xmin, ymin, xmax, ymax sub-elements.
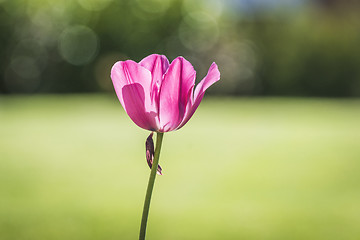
<box><xmin>0</xmin><ymin>0</ymin><xmax>360</xmax><ymax>97</ymax></box>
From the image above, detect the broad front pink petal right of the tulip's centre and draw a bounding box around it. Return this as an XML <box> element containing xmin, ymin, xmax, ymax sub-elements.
<box><xmin>159</xmin><ymin>57</ymin><xmax>196</xmax><ymax>132</ymax></box>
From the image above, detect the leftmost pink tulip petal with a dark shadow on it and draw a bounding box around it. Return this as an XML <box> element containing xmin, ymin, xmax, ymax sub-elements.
<box><xmin>111</xmin><ymin>60</ymin><xmax>158</xmax><ymax>131</ymax></box>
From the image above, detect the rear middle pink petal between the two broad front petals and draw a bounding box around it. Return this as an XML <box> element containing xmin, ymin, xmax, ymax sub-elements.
<box><xmin>139</xmin><ymin>54</ymin><xmax>169</xmax><ymax>109</ymax></box>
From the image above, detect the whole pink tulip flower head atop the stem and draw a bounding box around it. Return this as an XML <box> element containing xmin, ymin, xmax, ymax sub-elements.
<box><xmin>111</xmin><ymin>54</ymin><xmax>220</xmax><ymax>132</ymax></box>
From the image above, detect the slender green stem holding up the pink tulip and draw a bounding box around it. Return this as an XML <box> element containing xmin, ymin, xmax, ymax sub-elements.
<box><xmin>139</xmin><ymin>132</ymin><xmax>164</xmax><ymax>240</ymax></box>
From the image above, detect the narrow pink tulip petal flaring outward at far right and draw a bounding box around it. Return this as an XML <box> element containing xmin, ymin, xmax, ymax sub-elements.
<box><xmin>177</xmin><ymin>63</ymin><xmax>220</xmax><ymax>129</ymax></box>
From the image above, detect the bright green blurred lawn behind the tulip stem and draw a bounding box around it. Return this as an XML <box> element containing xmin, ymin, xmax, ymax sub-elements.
<box><xmin>0</xmin><ymin>95</ymin><xmax>360</xmax><ymax>240</ymax></box>
